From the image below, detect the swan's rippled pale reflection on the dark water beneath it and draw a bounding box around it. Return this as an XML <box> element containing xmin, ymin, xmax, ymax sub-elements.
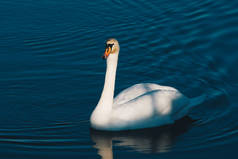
<box><xmin>91</xmin><ymin>117</ymin><xmax>194</xmax><ymax>159</ymax></box>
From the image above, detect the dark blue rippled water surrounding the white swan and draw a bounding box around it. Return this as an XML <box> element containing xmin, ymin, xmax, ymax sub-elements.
<box><xmin>0</xmin><ymin>0</ymin><xmax>238</xmax><ymax>159</ymax></box>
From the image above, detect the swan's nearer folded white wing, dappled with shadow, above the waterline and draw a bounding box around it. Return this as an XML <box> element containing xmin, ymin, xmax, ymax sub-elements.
<box><xmin>109</xmin><ymin>89</ymin><xmax>189</xmax><ymax>130</ymax></box>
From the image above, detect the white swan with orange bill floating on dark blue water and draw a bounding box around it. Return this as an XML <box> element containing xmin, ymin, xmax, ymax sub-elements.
<box><xmin>90</xmin><ymin>39</ymin><xmax>205</xmax><ymax>131</ymax></box>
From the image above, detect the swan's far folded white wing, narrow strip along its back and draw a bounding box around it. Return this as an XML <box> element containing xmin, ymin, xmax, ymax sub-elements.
<box><xmin>113</xmin><ymin>83</ymin><xmax>176</xmax><ymax>106</ymax></box>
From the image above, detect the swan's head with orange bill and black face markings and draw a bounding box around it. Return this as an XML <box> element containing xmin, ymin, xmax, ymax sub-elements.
<box><xmin>102</xmin><ymin>38</ymin><xmax>120</xmax><ymax>59</ymax></box>
